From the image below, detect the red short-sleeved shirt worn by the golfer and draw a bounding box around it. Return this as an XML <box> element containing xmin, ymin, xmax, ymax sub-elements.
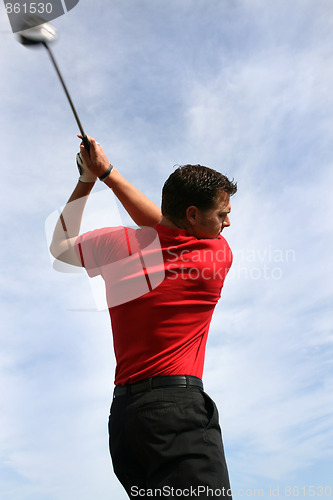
<box><xmin>75</xmin><ymin>224</ymin><xmax>232</xmax><ymax>385</ymax></box>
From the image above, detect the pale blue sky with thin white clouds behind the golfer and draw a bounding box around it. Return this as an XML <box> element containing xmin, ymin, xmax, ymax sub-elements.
<box><xmin>0</xmin><ymin>0</ymin><xmax>333</xmax><ymax>500</ymax></box>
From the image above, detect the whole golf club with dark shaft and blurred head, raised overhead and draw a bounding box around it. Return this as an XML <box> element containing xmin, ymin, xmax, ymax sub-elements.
<box><xmin>17</xmin><ymin>16</ymin><xmax>90</xmax><ymax>153</ymax></box>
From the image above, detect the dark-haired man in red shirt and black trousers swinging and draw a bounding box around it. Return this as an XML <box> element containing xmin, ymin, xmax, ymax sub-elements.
<box><xmin>50</xmin><ymin>137</ymin><xmax>237</xmax><ymax>498</ymax></box>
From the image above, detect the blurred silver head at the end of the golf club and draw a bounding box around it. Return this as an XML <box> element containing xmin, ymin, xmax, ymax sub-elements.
<box><xmin>17</xmin><ymin>16</ymin><xmax>58</xmax><ymax>46</ymax></box>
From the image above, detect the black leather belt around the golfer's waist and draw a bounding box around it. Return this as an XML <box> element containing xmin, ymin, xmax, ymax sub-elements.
<box><xmin>113</xmin><ymin>375</ymin><xmax>203</xmax><ymax>398</ymax></box>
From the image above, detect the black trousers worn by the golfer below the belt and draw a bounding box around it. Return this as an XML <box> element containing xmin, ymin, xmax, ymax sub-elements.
<box><xmin>109</xmin><ymin>387</ymin><xmax>231</xmax><ymax>499</ymax></box>
